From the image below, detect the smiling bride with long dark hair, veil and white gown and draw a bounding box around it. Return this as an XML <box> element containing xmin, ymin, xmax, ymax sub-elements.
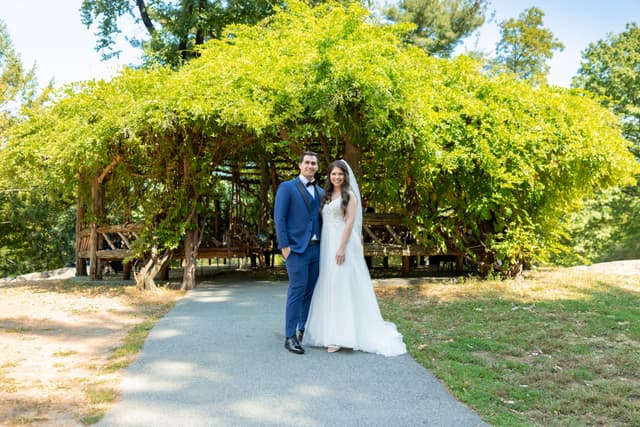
<box><xmin>303</xmin><ymin>160</ymin><xmax>407</xmax><ymax>356</ymax></box>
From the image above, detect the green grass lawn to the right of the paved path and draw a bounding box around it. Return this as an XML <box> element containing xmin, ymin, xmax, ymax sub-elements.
<box><xmin>376</xmin><ymin>269</ymin><xmax>640</xmax><ymax>427</ymax></box>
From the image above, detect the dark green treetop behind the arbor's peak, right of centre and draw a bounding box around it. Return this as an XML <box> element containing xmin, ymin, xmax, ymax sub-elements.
<box><xmin>384</xmin><ymin>0</ymin><xmax>487</xmax><ymax>57</ymax></box>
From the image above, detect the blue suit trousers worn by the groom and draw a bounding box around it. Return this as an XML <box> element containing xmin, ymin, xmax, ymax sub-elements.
<box><xmin>285</xmin><ymin>245</ymin><xmax>320</xmax><ymax>338</ymax></box>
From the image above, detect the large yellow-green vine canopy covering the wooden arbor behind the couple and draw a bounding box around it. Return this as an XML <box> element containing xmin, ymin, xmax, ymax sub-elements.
<box><xmin>5</xmin><ymin>2</ymin><xmax>638</xmax><ymax>273</ymax></box>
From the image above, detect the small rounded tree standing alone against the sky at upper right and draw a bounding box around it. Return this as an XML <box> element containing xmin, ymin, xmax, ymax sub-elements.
<box><xmin>495</xmin><ymin>7</ymin><xmax>564</xmax><ymax>82</ymax></box>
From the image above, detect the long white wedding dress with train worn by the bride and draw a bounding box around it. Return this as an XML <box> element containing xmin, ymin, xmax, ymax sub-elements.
<box><xmin>303</xmin><ymin>196</ymin><xmax>407</xmax><ymax>356</ymax></box>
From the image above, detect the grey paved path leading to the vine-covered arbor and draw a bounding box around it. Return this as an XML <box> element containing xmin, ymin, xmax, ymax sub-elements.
<box><xmin>97</xmin><ymin>279</ymin><xmax>487</xmax><ymax>427</ymax></box>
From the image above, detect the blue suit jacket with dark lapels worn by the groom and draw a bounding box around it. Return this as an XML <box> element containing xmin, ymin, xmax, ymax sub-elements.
<box><xmin>273</xmin><ymin>177</ymin><xmax>324</xmax><ymax>253</ymax></box>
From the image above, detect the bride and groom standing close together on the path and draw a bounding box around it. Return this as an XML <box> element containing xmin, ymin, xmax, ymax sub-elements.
<box><xmin>274</xmin><ymin>151</ymin><xmax>407</xmax><ymax>356</ymax></box>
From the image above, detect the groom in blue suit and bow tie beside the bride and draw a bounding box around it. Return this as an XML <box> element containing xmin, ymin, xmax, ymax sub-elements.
<box><xmin>273</xmin><ymin>151</ymin><xmax>323</xmax><ymax>354</ymax></box>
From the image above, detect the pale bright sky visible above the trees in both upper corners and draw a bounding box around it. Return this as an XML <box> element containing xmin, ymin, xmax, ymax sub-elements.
<box><xmin>0</xmin><ymin>0</ymin><xmax>640</xmax><ymax>87</ymax></box>
